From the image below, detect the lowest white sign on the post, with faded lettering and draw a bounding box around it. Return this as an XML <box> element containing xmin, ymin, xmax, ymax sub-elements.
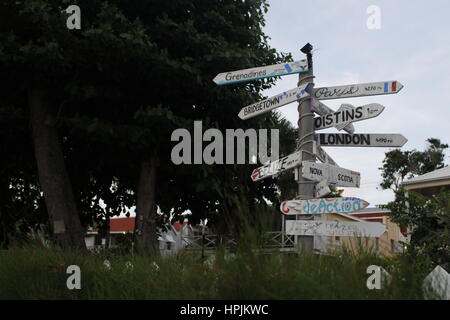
<box><xmin>286</xmin><ymin>220</ymin><xmax>386</xmax><ymax>238</ymax></box>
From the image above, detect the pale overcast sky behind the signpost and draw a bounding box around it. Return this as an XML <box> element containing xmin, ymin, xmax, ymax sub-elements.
<box><xmin>264</xmin><ymin>0</ymin><xmax>450</xmax><ymax>207</ymax></box>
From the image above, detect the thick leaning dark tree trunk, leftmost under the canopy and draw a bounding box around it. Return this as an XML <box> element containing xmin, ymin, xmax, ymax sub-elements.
<box><xmin>28</xmin><ymin>88</ymin><xmax>86</xmax><ymax>248</ymax></box>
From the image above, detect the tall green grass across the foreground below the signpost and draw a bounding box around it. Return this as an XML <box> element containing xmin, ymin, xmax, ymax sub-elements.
<box><xmin>0</xmin><ymin>236</ymin><xmax>431</xmax><ymax>299</ymax></box>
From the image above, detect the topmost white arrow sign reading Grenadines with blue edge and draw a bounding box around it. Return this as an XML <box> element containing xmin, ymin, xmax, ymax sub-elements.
<box><xmin>213</xmin><ymin>60</ymin><xmax>308</xmax><ymax>85</ymax></box>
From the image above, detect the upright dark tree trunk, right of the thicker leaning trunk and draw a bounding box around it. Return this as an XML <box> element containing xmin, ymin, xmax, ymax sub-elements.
<box><xmin>135</xmin><ymin>154</ymin><xmax>159</xmax><ymax>255</ymax></box>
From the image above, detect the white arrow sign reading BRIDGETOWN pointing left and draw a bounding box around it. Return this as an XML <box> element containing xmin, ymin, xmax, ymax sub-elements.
<box><xmin>238</xmin><ymin>83</ymin><xmax>312</xmax><ymax>120</ymax></box>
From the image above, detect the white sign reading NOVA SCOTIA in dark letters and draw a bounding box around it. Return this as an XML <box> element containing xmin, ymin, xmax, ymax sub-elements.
<box><xmin>302</xmin><ymin>161</ymin><xmax>361</xmax><ymax>188</ymax></box>
